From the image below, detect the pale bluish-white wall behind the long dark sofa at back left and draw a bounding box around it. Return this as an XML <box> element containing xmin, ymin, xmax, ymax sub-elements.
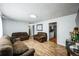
<box><xmin>3</xmin><ymin>19</ymin><xmax>29</xmax><ymax>35</ymax></box>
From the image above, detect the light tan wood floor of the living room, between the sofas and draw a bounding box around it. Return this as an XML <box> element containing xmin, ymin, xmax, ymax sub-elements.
<box><xmin>23</xmin><ymin>38</ymin><xmax>67</xmax><ymax>56</ymax></box>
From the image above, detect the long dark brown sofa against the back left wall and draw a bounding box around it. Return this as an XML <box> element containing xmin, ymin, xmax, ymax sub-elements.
<box><xmin>11</xmin><ymin>32</ymin><xmax>29</xmax><ymax>42</ymax></box>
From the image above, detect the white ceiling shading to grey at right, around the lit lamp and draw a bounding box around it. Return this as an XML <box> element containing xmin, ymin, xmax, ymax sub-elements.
<box><xmin>0</xmin><ymin>3</ymin><xmax>79</xmax><ymax>23</ymax></box>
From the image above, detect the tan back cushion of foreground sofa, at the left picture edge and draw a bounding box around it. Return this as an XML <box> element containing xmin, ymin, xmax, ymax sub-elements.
<box><xmin>0</xmin><ymin>37</ymin><xmax>13</xmax><ymax>56</ymax></box>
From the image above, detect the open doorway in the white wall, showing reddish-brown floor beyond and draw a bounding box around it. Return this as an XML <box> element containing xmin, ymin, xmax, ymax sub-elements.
<box><xmin>49</xmin><ymin>22</ymin><xmax>57</xmax><ymax>43</ymax></box>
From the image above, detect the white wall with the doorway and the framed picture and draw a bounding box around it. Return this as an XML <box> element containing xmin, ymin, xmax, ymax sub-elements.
<box><xmin>34</xmin><ymin>14</ymin><xmax>76</xmax><ymax>46</ymax></box>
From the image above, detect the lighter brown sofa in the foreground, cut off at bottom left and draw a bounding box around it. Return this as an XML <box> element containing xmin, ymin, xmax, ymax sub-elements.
<box><xmin>0</xmin><ymin>36</ymin><xmax>35</xmax><ymax>56</ymax></box>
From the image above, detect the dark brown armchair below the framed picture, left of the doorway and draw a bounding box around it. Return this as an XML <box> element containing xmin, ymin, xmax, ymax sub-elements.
<box><xmin>34</xmin><ymin>32</ymin><xmax>47</xmax><ymax>43</ymax></box>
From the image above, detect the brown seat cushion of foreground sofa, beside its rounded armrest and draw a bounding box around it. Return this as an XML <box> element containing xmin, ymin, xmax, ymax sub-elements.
<box><xmin>13</xmin><ymin>41</ymin><xmax>28</xmax><ymax>55</ymax></box>
